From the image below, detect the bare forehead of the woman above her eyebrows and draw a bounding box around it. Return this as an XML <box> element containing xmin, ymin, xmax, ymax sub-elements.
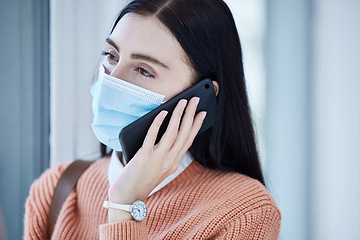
<box><xmin>110</xmin><ymin>13</ymin><xmax>186</xmax><ymax>65</ymax></box>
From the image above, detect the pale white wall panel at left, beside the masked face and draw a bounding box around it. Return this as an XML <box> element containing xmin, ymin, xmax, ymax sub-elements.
<box><xmin>50</xmin><ymin>0</ymin><xmax>126</xmax><ymax>165</ymax></box>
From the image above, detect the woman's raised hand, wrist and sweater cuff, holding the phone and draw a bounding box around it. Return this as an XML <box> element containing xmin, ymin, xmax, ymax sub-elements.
<box><xmin>100</xmin><ymin>98</ymin><xmax>206</xmax><ymax>239</ymax></box>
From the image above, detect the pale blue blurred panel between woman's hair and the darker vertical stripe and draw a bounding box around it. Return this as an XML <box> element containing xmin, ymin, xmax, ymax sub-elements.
<box><xmin>264</xmin><ymin>0</ymin><xmax>312</xmax><ymax>240</ymax></box>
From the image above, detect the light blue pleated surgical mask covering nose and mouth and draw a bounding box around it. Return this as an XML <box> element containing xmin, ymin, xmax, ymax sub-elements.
<box><xmin>91</xmin><ymin>64</ymin><xmax>165</xmax><ymax>151</ymax></box>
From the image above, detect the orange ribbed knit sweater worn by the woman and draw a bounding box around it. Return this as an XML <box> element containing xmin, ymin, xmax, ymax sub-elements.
<box><xmin>25</xmin><ymin>158</ymin><xmax>281</xmax><ymax>240</ymax></box>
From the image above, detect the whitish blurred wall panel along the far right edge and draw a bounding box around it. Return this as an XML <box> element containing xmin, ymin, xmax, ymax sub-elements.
<box><xmin>312</xmin><ymin>0</ymin><xmax>360</xmax><ymax>240</ymax></box>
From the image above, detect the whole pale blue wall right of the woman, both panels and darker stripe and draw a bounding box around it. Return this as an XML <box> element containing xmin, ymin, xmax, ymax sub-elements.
<box><xmin>265</xmin><ymin>0</ymin><xmax>360</xmax><ymax>240</ymax></box>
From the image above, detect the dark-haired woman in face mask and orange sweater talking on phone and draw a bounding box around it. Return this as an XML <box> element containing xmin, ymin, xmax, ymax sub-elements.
<box><xmin>25</xmin><ymin>0</ymin><xmax>281</xmax><ymax>239</ymax></box>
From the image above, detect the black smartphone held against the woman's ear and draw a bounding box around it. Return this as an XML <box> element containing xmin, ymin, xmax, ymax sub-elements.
<box><xmin>119</xmin><ymin>78</ymin><xmax>218</xmax><ymax>163</ymax></box>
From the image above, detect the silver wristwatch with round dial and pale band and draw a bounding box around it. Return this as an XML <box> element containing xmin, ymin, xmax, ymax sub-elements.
<box><xmin>103</xmin><ymin>200</ymin><xmax>147</xmax><ymax>221</ymax></box>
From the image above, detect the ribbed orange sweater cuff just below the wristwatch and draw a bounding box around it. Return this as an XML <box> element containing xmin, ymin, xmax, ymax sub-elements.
<box><xmin>100</xmin><ymin>220</ymin><xmax>148</xmax><ymax>240</ymax></box>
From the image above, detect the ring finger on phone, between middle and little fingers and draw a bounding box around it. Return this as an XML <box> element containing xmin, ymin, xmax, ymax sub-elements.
<box><xmin>172</xmin><ymin>97</ymin><xmax>200</xmax><ymax>154</ymax></box>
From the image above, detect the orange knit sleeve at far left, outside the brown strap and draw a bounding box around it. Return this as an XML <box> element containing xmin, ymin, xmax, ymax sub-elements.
<box><xmin>24</xmin><ymin>163</ymin><xmax>69</xmax><ymax>239</ymax></box>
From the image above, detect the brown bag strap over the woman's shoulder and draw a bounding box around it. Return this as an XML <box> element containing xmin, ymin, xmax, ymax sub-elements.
<box><xmin>47</xmin><ymin>160</ymin><xmax>93</xmax><ymax>239</ymax></box>
